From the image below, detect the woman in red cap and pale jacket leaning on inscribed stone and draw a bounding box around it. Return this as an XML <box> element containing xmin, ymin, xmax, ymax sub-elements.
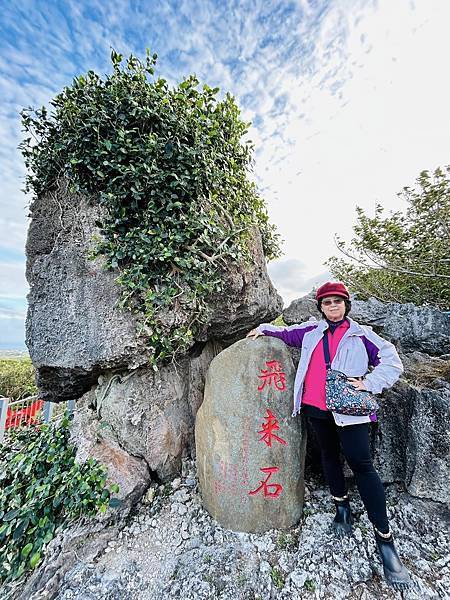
<box><xmin>247</xmin><ymin>282</ymin><xmax>410</xmax><ymax>589</ymax></box>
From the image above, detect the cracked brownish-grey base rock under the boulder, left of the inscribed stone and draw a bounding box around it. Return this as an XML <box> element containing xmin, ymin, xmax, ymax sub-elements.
<box><xmin>74</xmin><ymin>342</ymin><xmax>222</xmax><ymax>482</ymax></box>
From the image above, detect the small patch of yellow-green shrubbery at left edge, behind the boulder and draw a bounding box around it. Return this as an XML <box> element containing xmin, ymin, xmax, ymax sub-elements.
<box><xmin>0</xmin><ymin>357</ymin><xmax>37</xmax><ymax>400</ymax></box>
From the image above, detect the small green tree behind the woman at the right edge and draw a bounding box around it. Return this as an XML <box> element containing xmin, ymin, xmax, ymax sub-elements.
<box><xmin>327</xmin><ymin>166</ymin><xmax>450</xmax><ymax>310</ymax></box>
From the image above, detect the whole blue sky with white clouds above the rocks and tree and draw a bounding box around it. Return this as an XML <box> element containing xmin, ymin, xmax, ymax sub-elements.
<box><xmin>0</xmin><ymin>0</ymin><xmax>450</xmax><ymax>349</ymax></box>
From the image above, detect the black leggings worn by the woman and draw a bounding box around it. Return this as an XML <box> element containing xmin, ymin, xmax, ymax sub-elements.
<box><xmin>309</xmin><ymin>417</ymin><xmax>389</xmax><ymax>533</ymax></box>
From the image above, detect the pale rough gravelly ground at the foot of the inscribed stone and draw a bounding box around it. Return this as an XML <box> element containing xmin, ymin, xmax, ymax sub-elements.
<box><xmin>57</xmin><ymin>461</ymin><xmax>450</xmax><ymax>600</ymax></box>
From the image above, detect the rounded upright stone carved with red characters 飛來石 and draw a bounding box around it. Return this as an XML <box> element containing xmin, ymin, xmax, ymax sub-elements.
<box><xmin>195</xmin><ymin>337</ymin><xmax>306</xmax><ymax>532</ymax></box>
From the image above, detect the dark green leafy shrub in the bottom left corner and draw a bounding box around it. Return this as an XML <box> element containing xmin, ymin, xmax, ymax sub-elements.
<box><xmin>0</xmin><ymin>418</ymin><xmax>118</xmax><ymax>584</ymax></box>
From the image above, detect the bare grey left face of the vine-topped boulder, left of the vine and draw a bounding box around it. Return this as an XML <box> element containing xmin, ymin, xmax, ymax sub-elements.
<box><xmin>26</xmin><ymin>183</ymin><xmax>149</xmax><ymax>401</ymax></box>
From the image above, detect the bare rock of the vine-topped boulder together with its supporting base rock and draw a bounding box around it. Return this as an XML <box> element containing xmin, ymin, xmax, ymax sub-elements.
<box><xmin>27</xmin><ymin>181</ymin><xmax>282</xmax><ymax>490</ymax></box>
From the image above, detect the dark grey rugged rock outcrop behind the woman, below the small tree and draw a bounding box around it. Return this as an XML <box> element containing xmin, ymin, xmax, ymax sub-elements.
<box><xmin>283</xmin><ymin>293</ymin><xmax>450</xmax><ymax>503</ymax></box>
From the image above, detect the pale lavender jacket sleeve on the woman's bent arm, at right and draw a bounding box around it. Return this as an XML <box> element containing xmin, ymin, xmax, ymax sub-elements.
<box><xmin>363</xmin><ymin>327</ymin><xmax>403</xmax><ymax>394</ymax></box>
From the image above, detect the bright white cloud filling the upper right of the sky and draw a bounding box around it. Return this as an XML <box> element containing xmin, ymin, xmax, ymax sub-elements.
<box><xmin>251</xmin><ymin>1</ymin><xmax>450</xmax><ymax>276</ymax></box>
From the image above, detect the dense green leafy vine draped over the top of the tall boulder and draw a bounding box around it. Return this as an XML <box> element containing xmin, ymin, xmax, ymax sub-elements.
<box><xmin>20</xmin><ymin>49</ymin><xmax>280</xmax><ymax>366</ymax></box>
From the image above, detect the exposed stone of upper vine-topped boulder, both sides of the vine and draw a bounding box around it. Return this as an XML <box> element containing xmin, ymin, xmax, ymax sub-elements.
<box><xmin>26</xmin><ymin>181</ymin><xmax>283</xmax><ymax>401</ymax></box>
